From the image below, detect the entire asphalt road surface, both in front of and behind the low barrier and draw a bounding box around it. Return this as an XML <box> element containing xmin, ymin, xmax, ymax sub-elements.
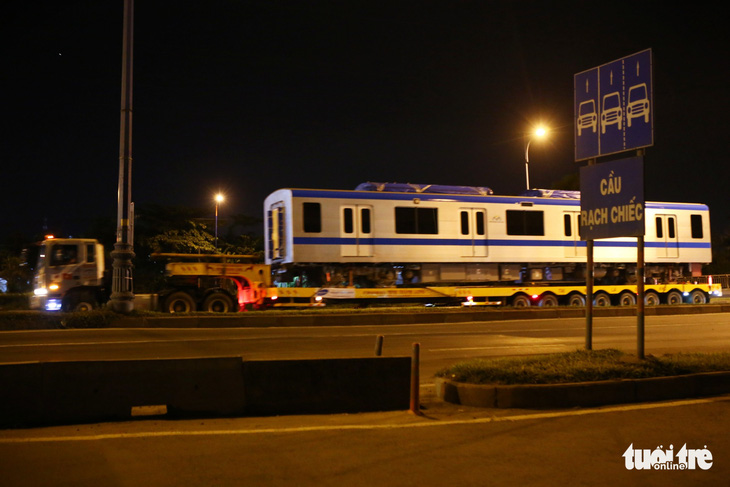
<box><xmin>0</xmin><ymin>315</ymin><xmax>730</xmax><ymax>487</ymax></box>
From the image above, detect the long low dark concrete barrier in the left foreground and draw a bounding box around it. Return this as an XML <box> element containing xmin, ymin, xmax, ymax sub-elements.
<box><xmin>0</xmin><ymin>357</ymin><xmax>410</xmax><ymax>428</ymax></box>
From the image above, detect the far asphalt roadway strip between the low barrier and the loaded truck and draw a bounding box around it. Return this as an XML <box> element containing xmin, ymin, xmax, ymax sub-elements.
<box><xmin>0</xmin><ymin>313</ymin><xmax>730</xmax><ymax>383</ymax></box>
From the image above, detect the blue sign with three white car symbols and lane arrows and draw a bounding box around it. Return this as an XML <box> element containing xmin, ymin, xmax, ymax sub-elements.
<box><xmin>573</xmin><ymin>49</ymin><xmax>654</xmax><ymax>161</ymax></box>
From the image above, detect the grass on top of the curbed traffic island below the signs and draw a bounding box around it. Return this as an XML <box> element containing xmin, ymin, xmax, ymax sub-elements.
<box><xmin>436</xmin><ymin>349</ymin><xmax>730</xmax><ymax>385</ymax></box>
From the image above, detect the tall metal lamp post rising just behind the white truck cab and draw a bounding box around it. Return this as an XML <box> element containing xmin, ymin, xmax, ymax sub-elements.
<box><xmin>109</xmin><ymin>0</ymin><xmax>134</xmax><ymax>313</ymax></box>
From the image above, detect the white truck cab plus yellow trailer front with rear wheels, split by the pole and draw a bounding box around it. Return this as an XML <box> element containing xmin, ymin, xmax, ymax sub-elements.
<box><xmin>30</xmin><ymin>238</ymin><xmax>271</xmax><ymax>313</ymax></box>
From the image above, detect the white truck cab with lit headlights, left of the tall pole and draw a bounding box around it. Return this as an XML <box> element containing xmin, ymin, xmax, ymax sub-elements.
<box><xmin>30</xmin><ymin>238</ymin><xmax>108</xmax><ymax>311</ymax></box>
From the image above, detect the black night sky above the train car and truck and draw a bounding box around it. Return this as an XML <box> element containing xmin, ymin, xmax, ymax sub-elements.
<box><xmin>5</xmin><ymin>0</ymin><xmax>730</xmax><ymax>239</ymax></box>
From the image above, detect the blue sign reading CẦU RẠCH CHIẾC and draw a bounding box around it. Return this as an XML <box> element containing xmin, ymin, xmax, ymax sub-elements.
<box><xmin>580</xmin><ymin>157</ymin><xmax>645</xmax><ymax>240</ymax></box>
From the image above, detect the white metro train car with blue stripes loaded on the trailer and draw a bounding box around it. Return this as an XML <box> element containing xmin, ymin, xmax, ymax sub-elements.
<box><xmin>264</xmin><ymin>183</ymin><xmax>712</xmax><ymax>287</ymax></box>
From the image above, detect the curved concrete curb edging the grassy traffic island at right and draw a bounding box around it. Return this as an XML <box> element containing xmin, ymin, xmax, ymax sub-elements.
<box><xmin>435</xmin><ymin>372</ymin><xmax>730</xmax><ymax>409</ymax></box>
